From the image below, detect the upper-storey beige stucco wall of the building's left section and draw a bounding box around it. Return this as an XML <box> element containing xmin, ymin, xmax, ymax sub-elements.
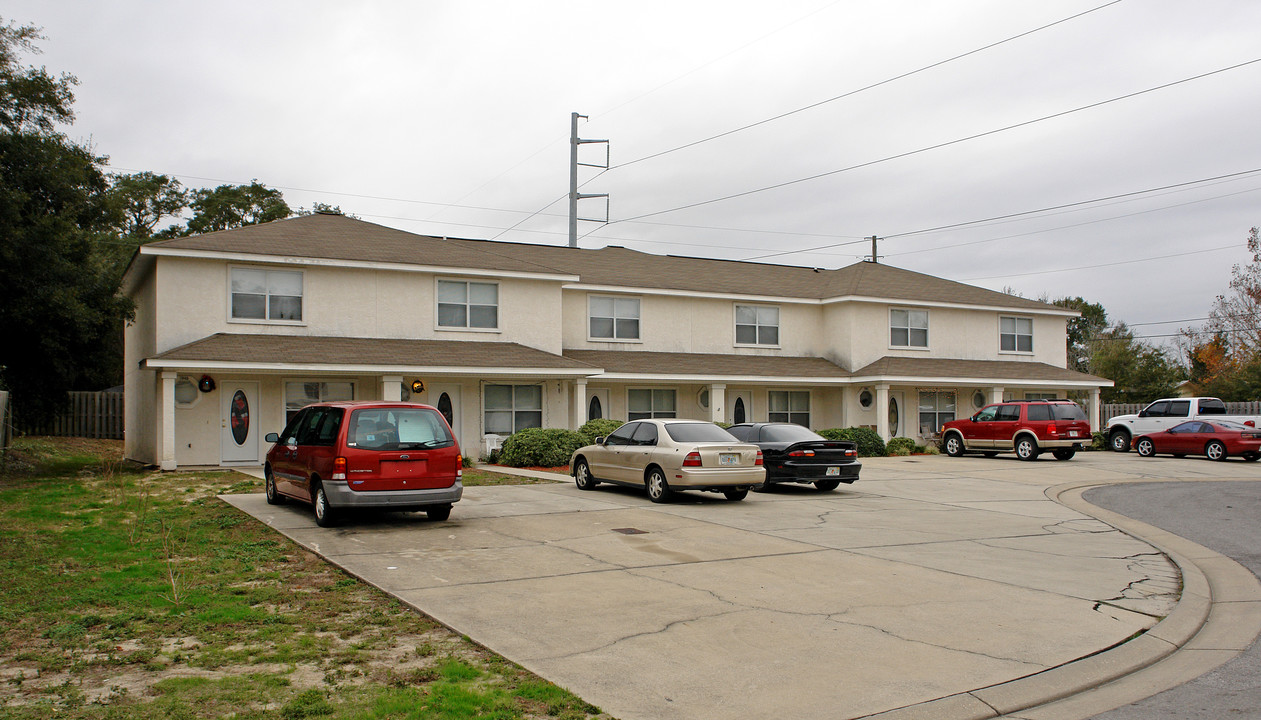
<box><xmin>156</xmin><ymin>257</ymin><xmax>561</xmax><ymax>353</ymax></box>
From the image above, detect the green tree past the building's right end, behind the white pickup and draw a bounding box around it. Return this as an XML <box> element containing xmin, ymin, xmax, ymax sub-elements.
<box><xmin>1091</xmin><ymin>323</ymin><xmax>1184</xmax><ymax>402</ymax></box>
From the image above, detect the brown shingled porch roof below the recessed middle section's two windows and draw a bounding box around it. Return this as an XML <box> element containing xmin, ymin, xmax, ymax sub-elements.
<box><xmin>565</xmin><ymin>351</ymin><xmax>850</xmax><ymax>380</ymax></box>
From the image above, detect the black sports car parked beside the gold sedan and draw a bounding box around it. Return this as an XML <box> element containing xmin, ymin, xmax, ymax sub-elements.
<box><xmin>726</xmin><ymin>422</ymin><xmax>863</xmax><ymax>491</ymax></box>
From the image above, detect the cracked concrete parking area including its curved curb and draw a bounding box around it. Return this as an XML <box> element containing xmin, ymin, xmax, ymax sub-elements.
<box><xmin>223</xmin><ymin>453</ymin><xmax>1261</xmax><ymax>720</ymax></box>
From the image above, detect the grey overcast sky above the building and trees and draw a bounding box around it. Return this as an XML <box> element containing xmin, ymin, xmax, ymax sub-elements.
<box><xmin>3</xmin><ymin>0</ymin><xmax>1261</xmax><ymax>350</ymax></box>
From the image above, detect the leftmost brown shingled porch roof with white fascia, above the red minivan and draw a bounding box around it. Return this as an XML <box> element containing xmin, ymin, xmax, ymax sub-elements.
<box><xmin>145</xmin><ymin>333</ymin><xmax>596</xmax><ymax>376</ymax></box>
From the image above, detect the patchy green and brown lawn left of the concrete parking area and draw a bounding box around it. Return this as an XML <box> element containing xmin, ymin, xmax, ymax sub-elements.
<box><xmin>0</xmin><ymin>438</ymin><xmax>608</xmax><ymax>720</ymax></box>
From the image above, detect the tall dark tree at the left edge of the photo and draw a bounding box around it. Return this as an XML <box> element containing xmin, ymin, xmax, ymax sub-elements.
<box><xmin>0</xmin><ymin>24</ymin><xmax>131</xmax><ymax>417</ymax></box>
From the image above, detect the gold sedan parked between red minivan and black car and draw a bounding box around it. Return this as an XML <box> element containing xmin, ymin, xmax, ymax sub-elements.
<box><xmin>569</xmin><ymin>420</ymin><xmax>767</xmax><ymax>503</ymax></box>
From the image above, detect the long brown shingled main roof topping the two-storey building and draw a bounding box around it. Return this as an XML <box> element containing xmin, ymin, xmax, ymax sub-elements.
<box><xmin>138</xmin><ymin>213</ymin><xmax>1077</xmax><ymax>315</ymax></box>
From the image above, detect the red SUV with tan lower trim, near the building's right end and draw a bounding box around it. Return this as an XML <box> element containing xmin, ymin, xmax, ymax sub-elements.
<box><xmin>942</xmin><ymin>400</ymin><xmax>1091</xmax><ymax>460</ymax></box>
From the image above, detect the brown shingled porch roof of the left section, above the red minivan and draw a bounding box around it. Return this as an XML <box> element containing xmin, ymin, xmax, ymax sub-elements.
<box><xmin>142</xmin><ymin>333</ymin><xmax>600</xmax><ymax>378</ymax></box>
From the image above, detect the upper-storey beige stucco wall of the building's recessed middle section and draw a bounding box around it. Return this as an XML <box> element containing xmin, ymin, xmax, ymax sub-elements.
<box><xmin>562</xmin><ymin>290</ymin><xmax>827</xmax><ymax>357</ymax></box>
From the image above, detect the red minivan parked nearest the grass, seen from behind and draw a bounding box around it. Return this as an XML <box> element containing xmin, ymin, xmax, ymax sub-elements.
<box><xmin>262</xmin><ymin>401</ymin><xmax>464</xmax><ymax>527</ymax></box>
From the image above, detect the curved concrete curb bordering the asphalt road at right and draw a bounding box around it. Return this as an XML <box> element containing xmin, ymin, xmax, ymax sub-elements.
<box><xmin>868</xmin><ymin>479</ymin><xmax>1261</xmax><ymax>720</ymax></box>
